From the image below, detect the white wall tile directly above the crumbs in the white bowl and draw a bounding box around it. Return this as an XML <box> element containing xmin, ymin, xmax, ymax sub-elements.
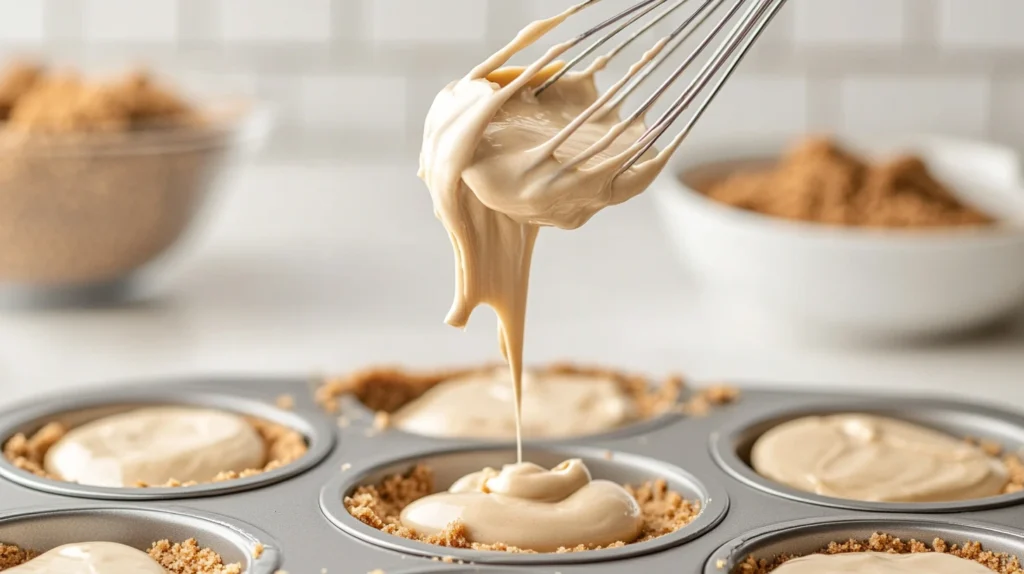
<box><xmin>840</xmin><ymin>77</ymin><xmax>990</xmax><ymax>136</ymax></box>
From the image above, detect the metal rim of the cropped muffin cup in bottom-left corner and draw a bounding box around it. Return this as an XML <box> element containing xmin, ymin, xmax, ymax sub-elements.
<box><xmin>0</xmin><ymin>503</ymin><xmax>283</xmax><ymax>574</ymax></box>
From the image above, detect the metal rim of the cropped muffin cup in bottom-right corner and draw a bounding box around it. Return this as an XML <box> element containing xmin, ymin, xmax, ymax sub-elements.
<box><xmin>701</xmin><ymin>514</ymin><xmax>1024</xmax><ymax>574</ymax></box>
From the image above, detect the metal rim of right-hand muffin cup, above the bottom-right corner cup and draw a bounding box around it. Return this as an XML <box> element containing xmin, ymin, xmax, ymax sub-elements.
<box><xmin>708</xmin><ymin>395</ymin><xmax>1024</xmax><ymax>511</ymax></box>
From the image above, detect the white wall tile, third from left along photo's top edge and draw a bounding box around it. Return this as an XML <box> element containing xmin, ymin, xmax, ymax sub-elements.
<box><xmin>220</xmin><ymin>0</ymin><xmax>332</xmax><ymax>43</ymax></box>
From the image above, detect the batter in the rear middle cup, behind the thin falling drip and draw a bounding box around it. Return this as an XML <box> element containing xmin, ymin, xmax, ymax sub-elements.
<box><xmin>391</xmin><ymin>368</ymin><xmax>637</xmax><ymax>438</ymax></box>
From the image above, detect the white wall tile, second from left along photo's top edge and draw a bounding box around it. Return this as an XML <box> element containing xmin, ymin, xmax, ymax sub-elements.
<box><xmin>81</xmin><ymin>0</ymin><xmax>178</xmax><ymax>43</ymax></box>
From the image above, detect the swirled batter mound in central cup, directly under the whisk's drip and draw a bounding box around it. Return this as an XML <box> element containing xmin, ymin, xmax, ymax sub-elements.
<box><xmin>401</xmin><ymin>458</ymin><xmax>643</xmax><ymax>553</ymax></box>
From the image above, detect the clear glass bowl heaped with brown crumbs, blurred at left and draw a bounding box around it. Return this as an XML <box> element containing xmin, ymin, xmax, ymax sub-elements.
<box><xmin>0</xmin><ymin>62</ymin><xmax>269</xmax><ymax>305</ymax></box>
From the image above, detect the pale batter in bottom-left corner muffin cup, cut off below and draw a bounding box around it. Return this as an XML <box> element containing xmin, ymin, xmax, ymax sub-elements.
<box><xmin>4</xmin><ymin>542</ymin><xmax>167</xmax><ymax>574</ymax></box>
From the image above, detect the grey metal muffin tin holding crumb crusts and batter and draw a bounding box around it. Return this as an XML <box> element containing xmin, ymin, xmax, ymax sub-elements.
<box><xmin>0</xmin><ymin>378</ymin><xmax>1024</xmax><ymax>574</ymax></box>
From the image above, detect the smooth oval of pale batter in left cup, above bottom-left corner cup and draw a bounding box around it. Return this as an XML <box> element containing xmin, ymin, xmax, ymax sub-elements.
<box><xmin>44</xmin><ymin>406</ymin><xmax>266</xmax><ymax>487</ymax></box>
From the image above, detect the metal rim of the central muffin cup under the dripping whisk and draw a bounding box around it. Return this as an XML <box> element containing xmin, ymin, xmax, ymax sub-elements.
<box><xmin>319</xmin><ymin>444</ymin><xmax>730</xmax><ymax>567</ymax></box>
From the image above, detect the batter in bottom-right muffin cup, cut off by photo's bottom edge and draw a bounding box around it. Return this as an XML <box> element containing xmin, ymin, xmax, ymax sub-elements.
<box><xmin>773</xmin><ymin>553</ymin><xmax>992</xmax><ymax>574</ymax></box>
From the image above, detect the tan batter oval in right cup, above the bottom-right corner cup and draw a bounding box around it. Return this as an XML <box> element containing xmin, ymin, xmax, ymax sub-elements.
<box><xmin>751</xmin><ymin>413</ymin><xmax>1008</xmax><ymax>502</ymax></box>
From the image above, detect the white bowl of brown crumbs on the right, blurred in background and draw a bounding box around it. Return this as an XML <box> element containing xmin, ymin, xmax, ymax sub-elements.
<box><xmin>653</xmin><ymin>136</ymin><xmax>1024</xmax><ymax>339</ymax></box>
